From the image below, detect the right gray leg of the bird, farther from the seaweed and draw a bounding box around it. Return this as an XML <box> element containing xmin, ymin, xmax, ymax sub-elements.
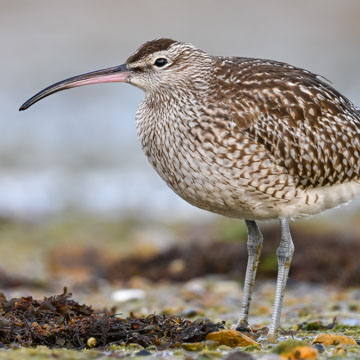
<box><xmin>267</xmin><ymin>219</ymin><xmax>294</xmax><ymax>341</ymax></box>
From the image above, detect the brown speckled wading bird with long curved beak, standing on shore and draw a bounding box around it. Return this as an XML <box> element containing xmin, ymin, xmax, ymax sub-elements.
<box><xmin>19</xmin><ymin>38</ymin><xmax>360</xmax><ymax>341</ymax></box>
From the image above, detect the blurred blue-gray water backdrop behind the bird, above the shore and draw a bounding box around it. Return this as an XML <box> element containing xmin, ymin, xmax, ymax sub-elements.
<box><xmin>0</xmin><ymin>0</ymin><xmax>360</xmax><ymax>219</ymax></box>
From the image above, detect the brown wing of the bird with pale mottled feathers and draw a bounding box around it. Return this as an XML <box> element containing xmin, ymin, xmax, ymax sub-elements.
<box><xmin>213</xmin><ymin>58</ymin><xmax>360</xmax><ymax>188</ymax></box>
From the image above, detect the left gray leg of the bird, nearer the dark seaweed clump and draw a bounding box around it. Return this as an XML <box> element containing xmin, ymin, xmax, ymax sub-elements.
<box><xmin>236</xmin><ymin>220</ymin><xmax>263</xmax><ymax>330</ymax></box>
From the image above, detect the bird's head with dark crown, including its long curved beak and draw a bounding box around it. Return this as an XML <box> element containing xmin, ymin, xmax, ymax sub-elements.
<box><xmin>20</xmin><ymin>38</ymin><xmax>213</xmax><ymax>110</ymax></box>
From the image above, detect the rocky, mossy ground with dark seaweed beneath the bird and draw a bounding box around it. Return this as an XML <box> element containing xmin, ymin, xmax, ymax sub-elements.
<box><xmin>0</xmin><ymin>215</ymin><xmax>360</xmax><ymax>360</ymax></box>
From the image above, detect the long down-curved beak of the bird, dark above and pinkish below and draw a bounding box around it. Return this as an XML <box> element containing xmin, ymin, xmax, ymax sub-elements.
<box><xmin>19</xmin><ymin>64</ymin><xmax>131</xmax><ymax>111</ymax></box>
